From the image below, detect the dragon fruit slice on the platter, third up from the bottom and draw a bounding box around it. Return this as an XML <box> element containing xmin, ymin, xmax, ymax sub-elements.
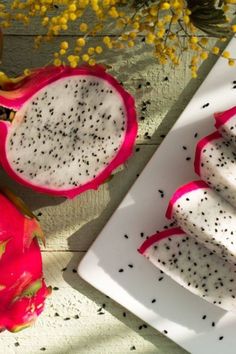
<box><xmin>194</xmin><ymin>131</ymin><xmax>236</xmax><ymax>207</ymax></box>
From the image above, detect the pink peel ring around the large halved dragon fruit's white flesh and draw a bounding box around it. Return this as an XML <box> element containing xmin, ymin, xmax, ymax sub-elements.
<box><xmin>0</xmin><ymin>65</ymin><xmax>138</xmax><ymax>198</ymax></box>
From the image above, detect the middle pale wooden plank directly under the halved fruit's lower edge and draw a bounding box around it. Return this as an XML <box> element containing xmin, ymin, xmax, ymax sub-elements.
<box><xmin>0</xmin><ymin>145</ymin><xmax>156</xmax><ymax>250</ymax></box>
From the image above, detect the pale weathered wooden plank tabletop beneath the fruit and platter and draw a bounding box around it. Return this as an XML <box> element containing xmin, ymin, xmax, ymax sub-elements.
<box><xmin>0</xmin><ymin>21</ymin><xmax>221</xmax><ymax>354</ymax></box>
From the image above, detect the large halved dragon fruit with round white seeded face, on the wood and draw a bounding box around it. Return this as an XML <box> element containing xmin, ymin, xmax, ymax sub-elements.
<box><xmin>0</xmin><ymin>66</ymin><xmax>137</xmax><ymax>198</ymax></box>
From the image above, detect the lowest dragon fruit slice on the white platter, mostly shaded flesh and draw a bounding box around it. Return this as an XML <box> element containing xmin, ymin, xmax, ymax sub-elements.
<box><xmin>139</xmin><ymin>228</ymin><xmax>236</xmax><ymax>311</ymax></box>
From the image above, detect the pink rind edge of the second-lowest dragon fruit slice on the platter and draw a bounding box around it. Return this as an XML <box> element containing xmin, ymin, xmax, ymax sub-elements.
<box><xmin>166</xmin><ymin>180</ymin><xmax>210</xmax><ymax>219</ymax></box>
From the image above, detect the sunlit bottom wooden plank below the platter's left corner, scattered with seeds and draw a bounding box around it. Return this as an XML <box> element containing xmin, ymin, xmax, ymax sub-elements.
<box><xmin>0</xmin><ymin>252</ymin><xmax>186</xmax><ymax>354</ymax></box>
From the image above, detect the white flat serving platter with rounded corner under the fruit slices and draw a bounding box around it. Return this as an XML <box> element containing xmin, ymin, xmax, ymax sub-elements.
<box><xmin>78</xmin><ymin>39</ymin><xmax>236</xmax><ymax>354</ymax></box>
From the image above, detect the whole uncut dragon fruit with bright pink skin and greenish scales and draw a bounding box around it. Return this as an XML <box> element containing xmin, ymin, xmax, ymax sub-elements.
<box><xmin>0</xmin><ymin>190</ymin><xmax>51</xmax><ymax>332</ymax></box>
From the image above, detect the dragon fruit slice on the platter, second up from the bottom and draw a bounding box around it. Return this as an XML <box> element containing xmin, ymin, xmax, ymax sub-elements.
<box><xmin>166</xmin><ymin>181</ymin><xmax>236</xmax><ymax>265</ymax></box>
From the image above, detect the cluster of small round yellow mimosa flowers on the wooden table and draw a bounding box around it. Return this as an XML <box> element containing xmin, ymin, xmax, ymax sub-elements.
<box><xmin>0</xmin><ymin>0</ymin><xmax>236</xmax><ymax>77</ymax></box>
